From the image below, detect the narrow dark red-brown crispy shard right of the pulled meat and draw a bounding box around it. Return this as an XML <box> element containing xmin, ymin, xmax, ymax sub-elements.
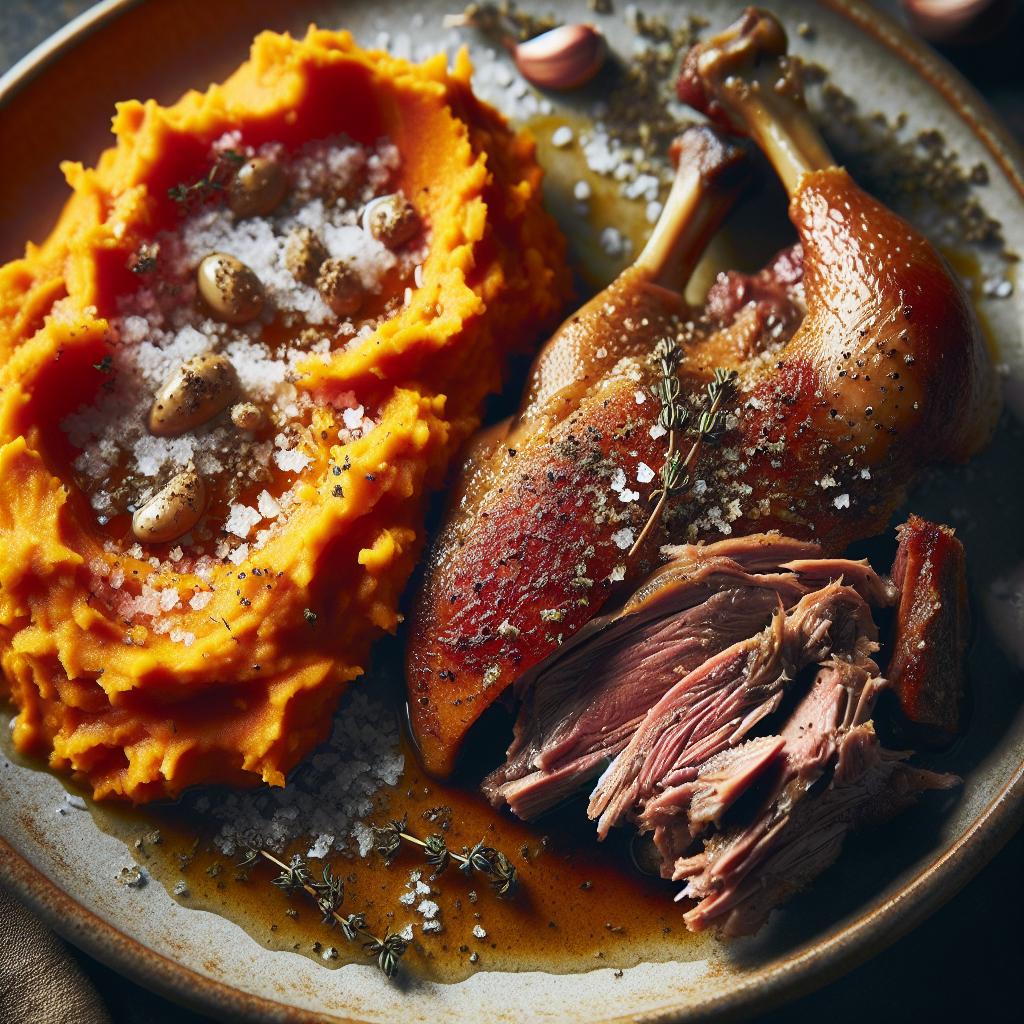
<box><xmin>888</xmin><ymin>516</ymin><xmax>971</xmax><ymax>742</ymax></box>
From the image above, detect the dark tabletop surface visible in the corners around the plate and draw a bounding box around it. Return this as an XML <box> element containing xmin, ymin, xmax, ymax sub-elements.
<box><xmin>0</xmin><ymin>0</ymin><xmax>1024</xmax><ymax>1024</ymax></box>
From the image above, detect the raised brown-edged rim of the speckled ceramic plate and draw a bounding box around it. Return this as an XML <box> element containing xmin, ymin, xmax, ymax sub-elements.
<box><xmin>0</xmin><ymin>0</ymin><xmax>1024</xmax><ymax>1024</ymax></box>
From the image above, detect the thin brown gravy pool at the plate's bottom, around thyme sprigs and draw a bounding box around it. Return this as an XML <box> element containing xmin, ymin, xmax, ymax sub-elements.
<box><xmin>83</xmin><ymin>733</ymin><xmax>703</xmax><ymax>982</ymax></box>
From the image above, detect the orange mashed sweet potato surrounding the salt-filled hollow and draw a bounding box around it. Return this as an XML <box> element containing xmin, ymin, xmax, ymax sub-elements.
<box><xmin>0</xmin><ymin>30</ymin><xmax>567</xmax><ymax>802</ymax></box>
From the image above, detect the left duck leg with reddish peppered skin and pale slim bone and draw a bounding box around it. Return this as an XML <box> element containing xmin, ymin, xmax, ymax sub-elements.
<box><xmin>407</xmin><ymin>127</ymin><xmax>742</xmax><ymax>774</ymax></box>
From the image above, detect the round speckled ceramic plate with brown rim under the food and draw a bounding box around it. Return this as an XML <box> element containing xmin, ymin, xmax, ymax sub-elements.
<box><xmin>0</xmin><ymin>0</ymin><xmax>1024</xmax><ymax>1022</ymax></box>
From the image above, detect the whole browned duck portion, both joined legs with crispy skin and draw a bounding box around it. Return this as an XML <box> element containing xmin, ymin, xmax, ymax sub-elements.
<box><xmin>407</xmin><ymin>9</ymin><xmax>998</xmax><ymax>774</ymax></box>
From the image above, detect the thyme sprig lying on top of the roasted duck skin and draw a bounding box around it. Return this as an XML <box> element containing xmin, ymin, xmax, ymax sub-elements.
<box><xmin>627</xmin><ymin>346</ymin><xmax>737</xmax><ymax>559</ymax></box>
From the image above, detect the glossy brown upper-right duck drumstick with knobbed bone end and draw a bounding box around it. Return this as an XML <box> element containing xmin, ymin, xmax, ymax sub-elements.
<box><xmin>679</xmin><ymin>8</ymin><xmax>998</xmax><ymax>468</ymax></box>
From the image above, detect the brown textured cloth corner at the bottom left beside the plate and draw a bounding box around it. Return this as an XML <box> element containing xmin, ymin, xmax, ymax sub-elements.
<box><xmin>0</xmin><ymin>887</ymin><xmax>111</xmax><ymax>1024</ymax></box>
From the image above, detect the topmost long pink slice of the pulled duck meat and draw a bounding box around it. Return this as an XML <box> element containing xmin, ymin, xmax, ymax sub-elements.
<box><xmin>483</xmin><ymin>535</ymin><xmax>892</xmax><ymax>818</ymax></box>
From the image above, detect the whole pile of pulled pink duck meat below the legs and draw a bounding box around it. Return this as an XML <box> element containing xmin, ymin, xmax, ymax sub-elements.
<box><xmin>484</xmin><ymin>524</ymin><xmax>957</xmax><ymax>936</ymax></box>
